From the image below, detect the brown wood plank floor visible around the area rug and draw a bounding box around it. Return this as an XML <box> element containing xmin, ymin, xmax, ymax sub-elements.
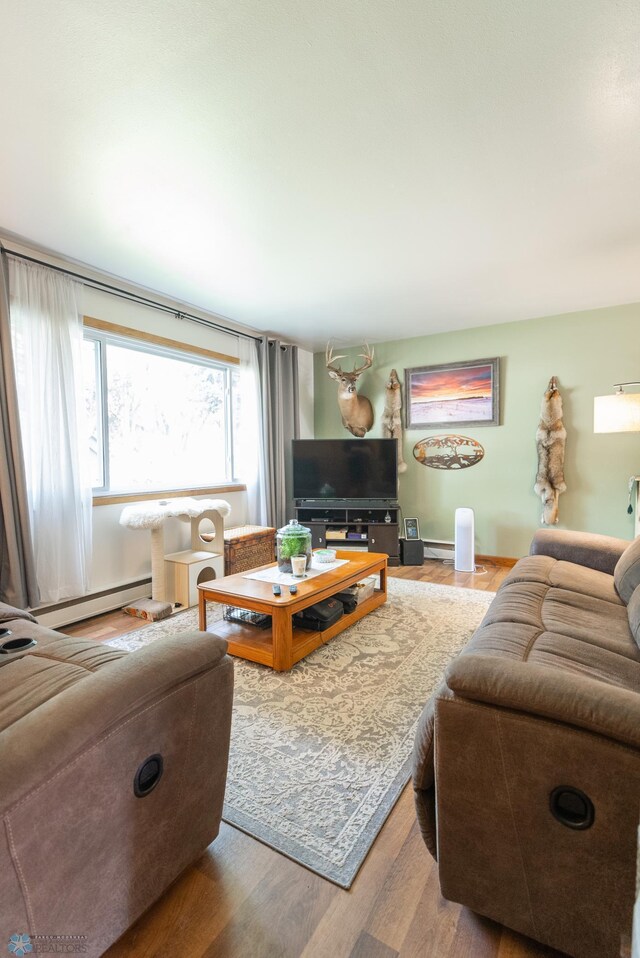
<box><xmin>64</xmin><ymin>560</ymin><xmax>559</xmax><ymax>958</ymax></box>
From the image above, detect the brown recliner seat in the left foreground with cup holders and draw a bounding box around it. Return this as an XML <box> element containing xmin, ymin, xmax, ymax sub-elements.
<box><xmin>0</xmin><ymin>605</ymin><xmax>233</xmax><ymax>956</ymax></box>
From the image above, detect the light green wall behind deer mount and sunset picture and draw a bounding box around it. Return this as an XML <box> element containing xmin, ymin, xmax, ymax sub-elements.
<box><xmin>314</xmin><ymin>304</ymin><xmax>640</xmax><ymax>556</ymax></box>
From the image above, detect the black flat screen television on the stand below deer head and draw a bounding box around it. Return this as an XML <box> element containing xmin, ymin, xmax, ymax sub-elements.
<box><xmin>292</xmin><ymin>439</ymin><xmax>398</xmax><ymax>500</ymax></box>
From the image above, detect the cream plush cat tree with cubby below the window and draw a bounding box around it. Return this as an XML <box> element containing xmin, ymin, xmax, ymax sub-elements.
<box><xmin>120</xmin><ymin>498</ymin><xmax>231</xmax><ymax>619</ymax></box>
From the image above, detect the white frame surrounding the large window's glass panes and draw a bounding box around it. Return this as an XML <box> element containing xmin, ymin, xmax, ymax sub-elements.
<box><xmin>84</xmin><ymin>326</ymin><xmax>241</xmax><ymax>498</ymax></box>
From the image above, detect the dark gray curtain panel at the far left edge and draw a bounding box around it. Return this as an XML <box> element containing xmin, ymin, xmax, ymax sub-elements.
<box><xmin>0</xmin><ymin>252</ymin><xmax>39</xmax><ymax>609</ymax></box>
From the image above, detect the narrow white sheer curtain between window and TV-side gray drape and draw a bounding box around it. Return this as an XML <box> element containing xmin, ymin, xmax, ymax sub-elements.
<box><xmin>234</xmin><ymin>337</ymin><xmax>269</xmax><ymax>526</ymax></box>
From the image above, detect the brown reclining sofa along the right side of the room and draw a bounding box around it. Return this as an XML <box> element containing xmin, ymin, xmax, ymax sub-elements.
<box><xmin>414</xmin><ymin>531</ymin><xmax>640</xmax><ymax>958</ymax></box>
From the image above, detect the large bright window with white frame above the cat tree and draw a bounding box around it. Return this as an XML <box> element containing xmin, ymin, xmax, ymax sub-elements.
<box><xmin>83</xmin><ymin>329</ymin><xmax>239</xmax><ymax>494</ymax></box>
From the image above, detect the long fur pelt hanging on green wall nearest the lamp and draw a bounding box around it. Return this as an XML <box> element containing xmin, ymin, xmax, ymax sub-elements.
<box><xmin>533</xmin><ymin>376</ymin><xmax>567</xmax><ymax>526</ymax></box>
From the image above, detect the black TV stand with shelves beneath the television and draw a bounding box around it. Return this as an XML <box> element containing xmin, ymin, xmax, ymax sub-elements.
<box><xmin>296</xmin><ymin>499</ymin><xmax>400</xmax><ymax>566</ymax></box>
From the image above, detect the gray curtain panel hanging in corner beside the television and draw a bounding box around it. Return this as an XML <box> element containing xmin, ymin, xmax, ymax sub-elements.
<box><xmin>258</xmin><ymin>336</ymin><xmax>300</xmax><ymax>529</ymax></box>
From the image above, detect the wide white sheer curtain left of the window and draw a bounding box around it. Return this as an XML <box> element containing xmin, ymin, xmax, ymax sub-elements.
<box><xmin>9</xmin><ymin>257</ymin><xmax>91</xmax><ymax>604</ymax></box>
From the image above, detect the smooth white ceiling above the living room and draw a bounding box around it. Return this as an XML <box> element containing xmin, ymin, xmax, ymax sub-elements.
<box><xmin>0</xmin><ymin>0</ymin><xmax>640</xmax><ymax>348</ymax></box>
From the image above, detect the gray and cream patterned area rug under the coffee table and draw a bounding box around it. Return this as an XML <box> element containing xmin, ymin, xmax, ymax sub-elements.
<box><xmin>109</xmin><ymin>578</ymin><xmax>493</xmax><ymax>888</ymax></box>
